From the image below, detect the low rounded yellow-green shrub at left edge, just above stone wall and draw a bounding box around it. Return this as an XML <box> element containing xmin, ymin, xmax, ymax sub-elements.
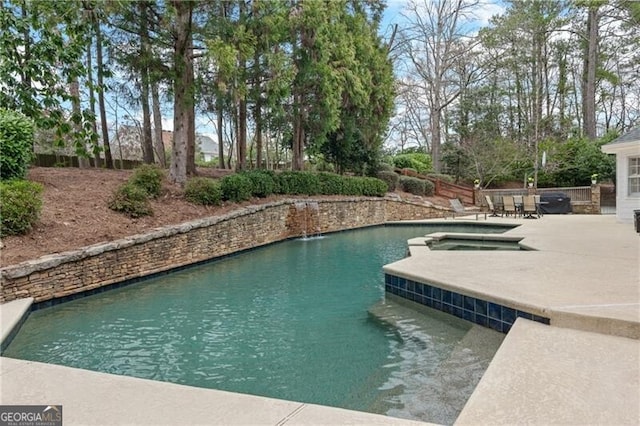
<box><xmin>0</xmin><ymin>180</ymin><xmax>42</xmax><ymax>237</ymax></box>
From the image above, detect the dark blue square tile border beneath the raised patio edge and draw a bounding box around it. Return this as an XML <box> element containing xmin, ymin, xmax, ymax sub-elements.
<box><xmin>384</xmin><ymin>274</ymin><xmax>549</xmax><ymax>333</ymax></box>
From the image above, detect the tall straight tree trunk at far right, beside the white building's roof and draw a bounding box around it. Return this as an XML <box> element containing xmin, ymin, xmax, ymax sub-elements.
<box><xmin>582</xmin><ymin>6</ymin><xmax>600</xmax><ymax>139</ymax></box>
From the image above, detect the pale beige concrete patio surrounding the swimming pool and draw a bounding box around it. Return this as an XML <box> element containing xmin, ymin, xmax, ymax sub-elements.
<box><xmin>0</xmin><ymin>215</ymin><xmax>640</xmax><ymax>425</ymax></box>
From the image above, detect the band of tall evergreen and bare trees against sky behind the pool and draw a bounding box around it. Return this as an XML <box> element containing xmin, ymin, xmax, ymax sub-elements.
<box><xmin>0</xmin><ymin>0</ymin><xmax>640</xmax><ymax>184</ymax></box>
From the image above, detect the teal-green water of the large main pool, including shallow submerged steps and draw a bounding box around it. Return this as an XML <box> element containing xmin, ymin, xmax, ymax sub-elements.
<box><xmin>3</xmin><ymin>226</ymin><xmax>502</xmax><ymax>424</ymax></box>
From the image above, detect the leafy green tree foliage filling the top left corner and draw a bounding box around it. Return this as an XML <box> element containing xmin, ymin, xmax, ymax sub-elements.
<box><xmin>0</xmin><ymin>1</ymin><xmax>93</xmax><ymax>150</ymax></box>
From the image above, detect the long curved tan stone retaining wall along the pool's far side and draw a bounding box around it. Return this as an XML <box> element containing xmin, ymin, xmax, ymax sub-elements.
<box><xmin>0</xmin><ymin>198</ymin><xmax>444</xmax><ymax>303</ymax></box>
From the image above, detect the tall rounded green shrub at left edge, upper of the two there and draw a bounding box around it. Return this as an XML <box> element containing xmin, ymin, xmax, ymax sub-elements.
<box><xmin>0</xmin><ymin>109</ymin><xmax>34</xmax><ymax>180</ymax></box>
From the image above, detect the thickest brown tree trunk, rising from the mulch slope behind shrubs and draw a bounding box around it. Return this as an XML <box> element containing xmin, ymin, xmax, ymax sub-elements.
<box><xmin>169</xmin><ymin>0</ymin><xmax>192</xmax><ymax>186</ymax></box>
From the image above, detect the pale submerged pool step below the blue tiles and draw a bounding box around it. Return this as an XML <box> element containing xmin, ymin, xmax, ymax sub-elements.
<box><xmin>369</xmin><ymin>295</ymin><xmax>504</xmax><ymax>424</ymax></box>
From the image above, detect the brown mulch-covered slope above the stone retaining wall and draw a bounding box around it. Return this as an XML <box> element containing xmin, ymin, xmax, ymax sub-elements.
<box><xmin>0</xmin><ymin>167</ymin><xmax>448</xmax><ymax>266</ymax></box>
